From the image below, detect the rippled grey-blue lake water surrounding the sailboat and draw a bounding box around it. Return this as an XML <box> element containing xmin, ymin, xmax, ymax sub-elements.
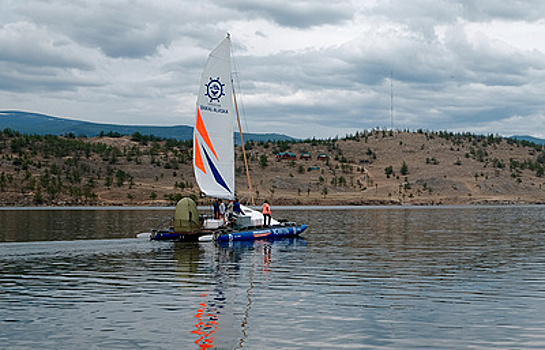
<box><xmin>0</xmin><ymin>206</ymin><xmax>545</xmax><ymax>350</ymax></box>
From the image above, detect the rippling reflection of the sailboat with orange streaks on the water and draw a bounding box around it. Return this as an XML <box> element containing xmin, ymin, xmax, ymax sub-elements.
<box><xmin>174</xmin><ymin>234</ymin><xmax>305</xmax><ymax>350</ymax></box>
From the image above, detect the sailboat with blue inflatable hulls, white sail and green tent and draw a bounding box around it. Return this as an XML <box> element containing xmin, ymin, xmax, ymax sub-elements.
<box><xmin>151</xmin><ymin>34</ymin><xmax>307</xmax><ymax>242</ymax></box>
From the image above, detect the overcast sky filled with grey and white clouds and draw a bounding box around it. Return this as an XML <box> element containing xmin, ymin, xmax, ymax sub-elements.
<box><xmin>0</xmin><ymin>0</ymin><xmax>545</xmax><ymax>138</ymax></box>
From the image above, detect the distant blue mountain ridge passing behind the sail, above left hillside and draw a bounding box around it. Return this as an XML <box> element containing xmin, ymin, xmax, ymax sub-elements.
<box><xmin>0</xmin><ymin>111</ymin><xmax>294</xmax><ymax>142</ymax></box>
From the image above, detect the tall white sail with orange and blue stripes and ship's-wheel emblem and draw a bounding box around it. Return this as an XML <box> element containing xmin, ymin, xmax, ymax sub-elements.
<box><xmin>193</xmin><ymin>36</ymin><xmax>236</xmax><ymax>199</ymax></box>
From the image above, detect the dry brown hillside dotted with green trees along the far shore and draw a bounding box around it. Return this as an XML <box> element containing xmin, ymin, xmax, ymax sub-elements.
<box><xmin>0</xmin><ymin>130</ymin><xmax>545</xmax><ymax>206</ymax></box>
